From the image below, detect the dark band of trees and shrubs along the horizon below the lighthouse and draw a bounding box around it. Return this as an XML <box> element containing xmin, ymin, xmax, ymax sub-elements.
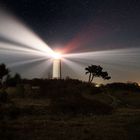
<box><xmin>4</xmin><ymin>77</ymin><xmax>140</xmax><ymax>96</ymax></box>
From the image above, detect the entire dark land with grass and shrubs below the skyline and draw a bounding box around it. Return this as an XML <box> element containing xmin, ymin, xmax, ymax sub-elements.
<box><xmin>0</xmin><ymin>63</ymin><xmax>140</xmax><ymax>140</ymax></box>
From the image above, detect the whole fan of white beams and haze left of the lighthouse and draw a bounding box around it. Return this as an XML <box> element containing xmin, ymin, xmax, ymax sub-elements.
<box><xmin>0</xmin><ymin>9</ymin><xmax>54</xmax><ymax>78</ymax></box>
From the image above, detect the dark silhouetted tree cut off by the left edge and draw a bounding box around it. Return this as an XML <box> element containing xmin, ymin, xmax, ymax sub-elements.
<box><xmin>0</xmin><ymin>63</ymin><xmax>10</xmax><ymax>86</ymax></box>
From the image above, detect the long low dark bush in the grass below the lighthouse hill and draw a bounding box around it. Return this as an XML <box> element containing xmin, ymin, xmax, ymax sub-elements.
<box><xmin>51</xmin><ymin>98</ymin><xmax>113</xmax><ymax>115</ymax></box>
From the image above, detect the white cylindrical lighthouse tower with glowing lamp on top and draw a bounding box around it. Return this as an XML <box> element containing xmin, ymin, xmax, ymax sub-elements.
<box><xmin>52</xmin><ymin>53</ymin><xmax>61</xmax><ymax>79</ymax></box>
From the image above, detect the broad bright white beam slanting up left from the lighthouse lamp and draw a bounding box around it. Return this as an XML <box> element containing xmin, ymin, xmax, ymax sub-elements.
<box><xmin>0</xmin><ymin>10</ymin><xmax>53</xmax><ymax>55</ymax></box>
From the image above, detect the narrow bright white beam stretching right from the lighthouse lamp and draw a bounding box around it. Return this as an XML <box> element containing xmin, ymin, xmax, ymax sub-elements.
<box><xmin>63</xmin><ymin>48</ymin><xmax>140</xmax><ymax>61</ymax></box>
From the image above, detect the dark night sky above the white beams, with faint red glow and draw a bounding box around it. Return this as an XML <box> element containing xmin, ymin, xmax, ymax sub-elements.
<box><xmin>1</xmin><ymin>0</ymin><xmax>140</xmax><ymax>82</ymax></box>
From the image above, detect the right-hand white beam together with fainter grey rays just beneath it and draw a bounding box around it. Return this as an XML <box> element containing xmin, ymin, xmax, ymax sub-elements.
<box><xmin>63</xmin><ymin>48</ymin><xmax>140</xmax><ymax>68</ymax></box>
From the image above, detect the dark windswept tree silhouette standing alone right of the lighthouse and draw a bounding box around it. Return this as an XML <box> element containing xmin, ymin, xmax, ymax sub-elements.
<box><xmin>85</xmin><ymin>65</ymin><xmax>111</xmax><ymax>83</ymax></box>
